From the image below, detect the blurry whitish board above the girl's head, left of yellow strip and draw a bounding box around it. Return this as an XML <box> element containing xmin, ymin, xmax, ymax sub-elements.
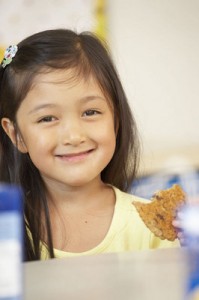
<box><xmin>0</xmin><ymin>0</ymin><xmax>96</xmax><ymax>47</ymax></box>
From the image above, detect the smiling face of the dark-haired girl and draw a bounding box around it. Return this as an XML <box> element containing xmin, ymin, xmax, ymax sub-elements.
<box><xmin>7</xmin><ymin>70</ymin><xmax>116</xmax><ymax>187</ymax></box>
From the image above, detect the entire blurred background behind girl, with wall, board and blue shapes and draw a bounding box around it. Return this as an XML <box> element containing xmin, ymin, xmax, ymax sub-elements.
<box><xmin>0</xmin><ymin>0</ymin><xmax>199</xmax><ymax>197</ymax></box>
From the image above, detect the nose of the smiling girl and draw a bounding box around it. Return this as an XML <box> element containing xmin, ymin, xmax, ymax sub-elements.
<box><xmin>61</xmin><ymin>121</ymin><xmax>85</xmax><ymax>146</ymax></box>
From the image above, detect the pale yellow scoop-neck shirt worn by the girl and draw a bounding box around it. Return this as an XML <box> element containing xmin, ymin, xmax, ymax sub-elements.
<box><xmin>41</xmin><ymin>187</ymin><xmax>179</xmax><ymax>259</ymax></box>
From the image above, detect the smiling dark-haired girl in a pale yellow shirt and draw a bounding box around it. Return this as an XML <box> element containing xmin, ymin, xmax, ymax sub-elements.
<box><xmin>0</xmin><ymin>29</ymin><xmax>180</xmax><ymax>260</ymax></box>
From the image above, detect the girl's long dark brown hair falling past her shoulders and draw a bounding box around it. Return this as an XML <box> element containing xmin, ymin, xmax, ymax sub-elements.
<box><xmin>0</xmin><ymin>29</ymin><xmax>139</xmax><ymax>260</ymax></box>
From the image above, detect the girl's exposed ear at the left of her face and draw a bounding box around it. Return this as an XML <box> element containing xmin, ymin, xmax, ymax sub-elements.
<box><xmin>1</xmin><ymin>118</ymin><xmax>28</xmax><ymax>153</ymax></box>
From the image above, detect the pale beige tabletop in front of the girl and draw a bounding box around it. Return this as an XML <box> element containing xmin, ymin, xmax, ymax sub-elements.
<box><xmin>24</xmin><ymin>249</ymin><xmax>186</xmax><ymax>300</ymax></box>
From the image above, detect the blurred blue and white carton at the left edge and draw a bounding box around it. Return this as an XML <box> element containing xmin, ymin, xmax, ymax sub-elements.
<box><xmin>0</xmin><ymin>184</ymin><xmax>23</xmax><ymax>300</ymax></box>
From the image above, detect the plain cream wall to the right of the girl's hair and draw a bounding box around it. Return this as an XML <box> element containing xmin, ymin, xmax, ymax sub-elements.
<box><xmin>108</xmin><ymin>0</ymin><xmax>199</xmax><ymax>170</ymax></box>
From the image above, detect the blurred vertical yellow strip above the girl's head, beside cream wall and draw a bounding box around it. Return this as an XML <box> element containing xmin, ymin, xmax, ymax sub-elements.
<box><xmin>95</xmin><ymin>0</ymin><xmax>107</xmax><ymax>40</ymax></box>
